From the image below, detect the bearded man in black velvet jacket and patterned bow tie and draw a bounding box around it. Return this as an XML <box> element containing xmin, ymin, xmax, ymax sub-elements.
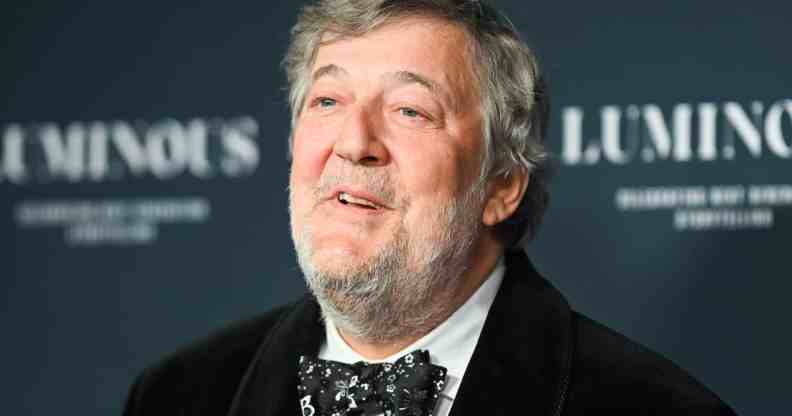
<box><xmin>125</xmin><ymin>0</ymin><xmax>733</xmax><ymax>416</ymax></box>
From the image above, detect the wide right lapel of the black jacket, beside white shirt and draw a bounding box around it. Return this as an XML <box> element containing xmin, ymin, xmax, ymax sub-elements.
<box><xmin>451</xmin><ymin>251</ymin><xmax>572</xmax><ymax>416</ymax></box>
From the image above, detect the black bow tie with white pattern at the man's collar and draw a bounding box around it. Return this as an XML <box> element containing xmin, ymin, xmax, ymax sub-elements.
<box><xmin>297</xmin><ymin>350</ymin><xmax>446</xmax><ymax>416</ymax></box>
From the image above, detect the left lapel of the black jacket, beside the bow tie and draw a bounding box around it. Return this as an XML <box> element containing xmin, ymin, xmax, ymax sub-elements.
<box><xmin>228</xmin><ymin>295</ymin><xmax>324</xmax><ymax>416</ymax></box>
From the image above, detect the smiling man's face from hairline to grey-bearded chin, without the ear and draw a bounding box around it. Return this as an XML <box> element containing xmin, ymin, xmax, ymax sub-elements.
<box><xmin>290</xmin><ymin>18</ymin><xmax>483</xmax><ymax>308</ymax></box>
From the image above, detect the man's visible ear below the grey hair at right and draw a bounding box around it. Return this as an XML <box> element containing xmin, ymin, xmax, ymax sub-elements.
<box><xmin>482</xmin><ymin>169</ymin><xmax>530</xmax><ymax>226</ymax></box>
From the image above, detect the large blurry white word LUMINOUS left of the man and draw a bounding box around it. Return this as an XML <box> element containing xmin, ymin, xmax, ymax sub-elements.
<box><xmin>0</xmin><ymin>117</ymin><xmax>260</xmax><ymax>184</ymax></box>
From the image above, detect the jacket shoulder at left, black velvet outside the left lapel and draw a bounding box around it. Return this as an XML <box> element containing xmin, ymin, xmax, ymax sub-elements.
<box><xmin>124</xmin><ymin>299</ymin><xmax>306</xmax><ymax>416</ymax></box>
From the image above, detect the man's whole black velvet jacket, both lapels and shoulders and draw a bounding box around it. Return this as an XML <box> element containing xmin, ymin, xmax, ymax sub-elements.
<box><xmin>124</xmin><ymin>252</ymin><xmax>734</xmax><ymax>416</ymax></box>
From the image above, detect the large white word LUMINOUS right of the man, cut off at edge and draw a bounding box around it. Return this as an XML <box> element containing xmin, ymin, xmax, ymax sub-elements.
<box><xmin>561</xmin><ymin>99</ymin><xmax>792</xmax><ymax>165</ymax></box>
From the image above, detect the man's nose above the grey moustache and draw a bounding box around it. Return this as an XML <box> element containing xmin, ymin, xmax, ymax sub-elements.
<box><xmin>333</xmin><ymin>105</ymin><xmax>388</xmax><ymax>166</ymax></box>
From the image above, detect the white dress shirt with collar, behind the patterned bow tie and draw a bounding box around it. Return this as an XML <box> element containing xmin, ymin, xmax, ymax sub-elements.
<box><xmin>319</xmin><ymin>257</ymin><xmax>506</xmax><ymax>416</ymax></box>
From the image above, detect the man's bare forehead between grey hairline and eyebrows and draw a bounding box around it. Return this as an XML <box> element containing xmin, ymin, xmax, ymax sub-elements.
<box><xmin>311</xmin><ymin>17</ymin><xmax>478</xmax><ymax>106</ymax></box>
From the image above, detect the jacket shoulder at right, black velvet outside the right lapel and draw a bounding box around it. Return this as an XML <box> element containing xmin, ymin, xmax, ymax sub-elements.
<box><xmin>567</xmin><ymin>312</ymin><xmax>734</xmax><ymax>415</ymax></box>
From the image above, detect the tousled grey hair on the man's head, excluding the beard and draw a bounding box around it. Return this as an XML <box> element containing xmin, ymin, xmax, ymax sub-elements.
<box><xmin>283</xmin><ymin>0</ymin><xmax>550</xmax><ymax>247</ymax></box>
